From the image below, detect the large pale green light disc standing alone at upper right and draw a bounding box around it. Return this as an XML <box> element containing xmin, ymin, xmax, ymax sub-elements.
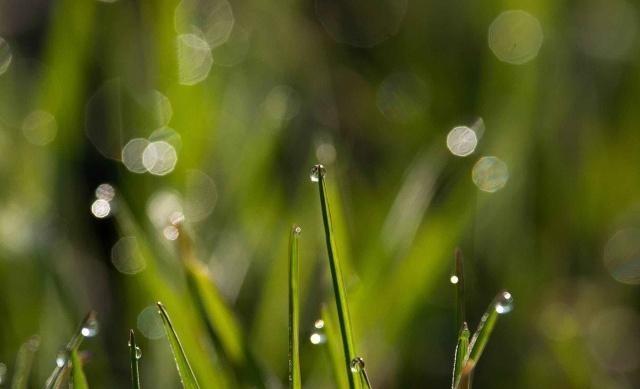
<box><xmin>488</xmin><ymin>10</ymin><xmax>544</xmax><ymax>65</ymax></box>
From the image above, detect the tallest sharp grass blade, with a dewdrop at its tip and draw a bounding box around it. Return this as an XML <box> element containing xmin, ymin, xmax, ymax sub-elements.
<box><xmin>311</xmin><ymin>165</ymin><xmax>356</xmax><ymax>388</ymax></box>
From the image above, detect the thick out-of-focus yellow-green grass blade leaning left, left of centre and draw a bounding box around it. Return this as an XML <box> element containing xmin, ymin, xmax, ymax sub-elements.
<box><xmin>178</xmin><ymin>225</ymin><xmax>264</xmax><ymax>388</ymax></box>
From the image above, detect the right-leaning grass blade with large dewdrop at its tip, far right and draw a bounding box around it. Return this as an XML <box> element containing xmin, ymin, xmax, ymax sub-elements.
<box><xmin>455</xmin><ymin>290</ymin><xmax>513</xmax><ymax>388</ymax></box>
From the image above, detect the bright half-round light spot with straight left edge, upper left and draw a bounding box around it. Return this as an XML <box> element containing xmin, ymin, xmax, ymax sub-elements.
<box><xmin>178</xmin><ymin>34</ymin><xmax>213</xmax><ymax>85</ymax></box>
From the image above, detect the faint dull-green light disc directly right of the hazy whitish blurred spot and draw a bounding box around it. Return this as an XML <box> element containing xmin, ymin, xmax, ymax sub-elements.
<box><xmin>184</xmin><ymin>170</ymin><xmax>218</xmax><ymax>224</ymax></box>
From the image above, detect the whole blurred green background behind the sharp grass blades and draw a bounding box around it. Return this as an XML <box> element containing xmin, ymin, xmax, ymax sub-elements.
<box><xmin>0</xmin><ymin>0</ymin><xmax>640</xmax><ymax>389</ymax></box>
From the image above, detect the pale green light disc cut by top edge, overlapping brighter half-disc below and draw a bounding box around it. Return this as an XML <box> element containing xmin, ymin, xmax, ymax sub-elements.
<box><xmin>174</xmin><ymin>0</ymin><xmax>235</xmax><ymax>48</ymax></box>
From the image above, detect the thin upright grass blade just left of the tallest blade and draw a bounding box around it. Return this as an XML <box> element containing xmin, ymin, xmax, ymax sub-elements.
<box><xmin>289</xmin><ymin>225</ymin><xmax>302</xmax><ymax>389</ymax></box>
